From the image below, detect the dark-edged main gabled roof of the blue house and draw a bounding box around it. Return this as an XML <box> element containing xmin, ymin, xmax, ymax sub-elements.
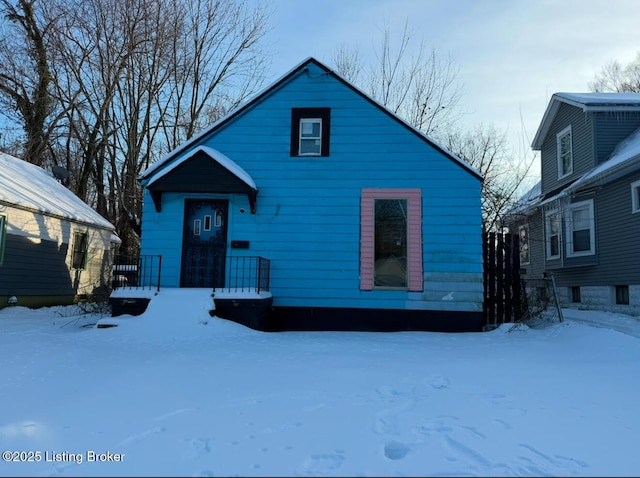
<box><xmin>138</xmin><ymin>58</ymin><xmax>482</xmax><ymax>185</ymax></box>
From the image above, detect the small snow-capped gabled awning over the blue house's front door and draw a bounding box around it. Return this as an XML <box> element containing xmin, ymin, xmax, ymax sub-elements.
<box><xmin>143</xmin><ymin>146</ymin><xmax>258</xmax><ymax>214</ymax></box>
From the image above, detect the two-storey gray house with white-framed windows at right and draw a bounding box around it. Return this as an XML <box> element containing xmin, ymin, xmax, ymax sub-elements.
<box><xmin>504</xmin><ymin>93</ymin><xmax>640</xmax><ymax>314</ymax></box>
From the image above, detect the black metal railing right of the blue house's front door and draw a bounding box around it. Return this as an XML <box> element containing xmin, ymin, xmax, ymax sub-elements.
<box><xmin>215</xmin><ymin>256</ymin><xmax>271</xmax><ymax>293</ymax></box>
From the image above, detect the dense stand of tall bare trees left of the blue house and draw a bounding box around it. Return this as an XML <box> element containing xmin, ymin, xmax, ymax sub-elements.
<box><xmin>0</xmin><ymin>0</ymin><xmax>270</xmax><ymax>252</ymax></box>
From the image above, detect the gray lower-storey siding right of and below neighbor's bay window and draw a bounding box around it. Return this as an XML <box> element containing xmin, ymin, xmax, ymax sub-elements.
<box><xmin>555</xmin><ymin>172</ymin><xmax>640</xmax><ymax>286</ymax></box>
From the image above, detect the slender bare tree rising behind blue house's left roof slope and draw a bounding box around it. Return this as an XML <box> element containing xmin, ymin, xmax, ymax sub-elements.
<box><xmin>158</xmin><ymin>0</ymin><xmax>271</xmax><ymax>149</ymax></box>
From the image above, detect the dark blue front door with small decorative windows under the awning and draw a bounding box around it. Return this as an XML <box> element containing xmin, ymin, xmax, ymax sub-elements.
<box><xmin>180</xmin><ymin>199</ymin><xmax>229</xmax><ymax>287</ymax></box>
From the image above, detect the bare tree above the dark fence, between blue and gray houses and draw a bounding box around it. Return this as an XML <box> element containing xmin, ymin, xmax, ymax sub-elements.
<box><xmin>445</xmin><ymin>124</ymin><xmax>534</xmax><ymax>231</ymax></box>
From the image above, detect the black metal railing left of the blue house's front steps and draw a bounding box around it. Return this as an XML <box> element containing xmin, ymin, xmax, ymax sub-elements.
<box><xmin>111</xmin><ymin>254</ymin><xmax>162</xmax><ymax>291</ymax></box>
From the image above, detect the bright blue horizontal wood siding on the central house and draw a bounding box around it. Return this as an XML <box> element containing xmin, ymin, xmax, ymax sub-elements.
<box><xmin>142</xmin><ymin>60</ymin><xmax>482</xmax><ymax>312</ymax></box>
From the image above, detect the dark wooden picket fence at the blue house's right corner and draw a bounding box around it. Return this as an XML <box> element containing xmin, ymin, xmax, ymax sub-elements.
<box><xmin>482</xmin><ymin>232</ymin><xmax>523</xmax><ymax>327</ymax></box>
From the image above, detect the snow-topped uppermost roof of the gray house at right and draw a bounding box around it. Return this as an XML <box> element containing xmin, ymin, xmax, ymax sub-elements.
<box><xmin>531</xmin><ymin>93</ymin><xmax>640</xmax><ymax>151</ymax></box>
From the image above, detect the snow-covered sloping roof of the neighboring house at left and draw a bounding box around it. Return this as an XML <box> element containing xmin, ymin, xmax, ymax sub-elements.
<box><xmin>0</xmin><ymin>153</ymin><xmax>115</xmax><ymax>230</ymax></box>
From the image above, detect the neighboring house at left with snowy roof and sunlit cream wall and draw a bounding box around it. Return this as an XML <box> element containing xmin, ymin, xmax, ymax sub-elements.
<box><xmin>0</xmin><ymin>153</ymin><xmax>120</xmax><ymax>309</ymax></box>
